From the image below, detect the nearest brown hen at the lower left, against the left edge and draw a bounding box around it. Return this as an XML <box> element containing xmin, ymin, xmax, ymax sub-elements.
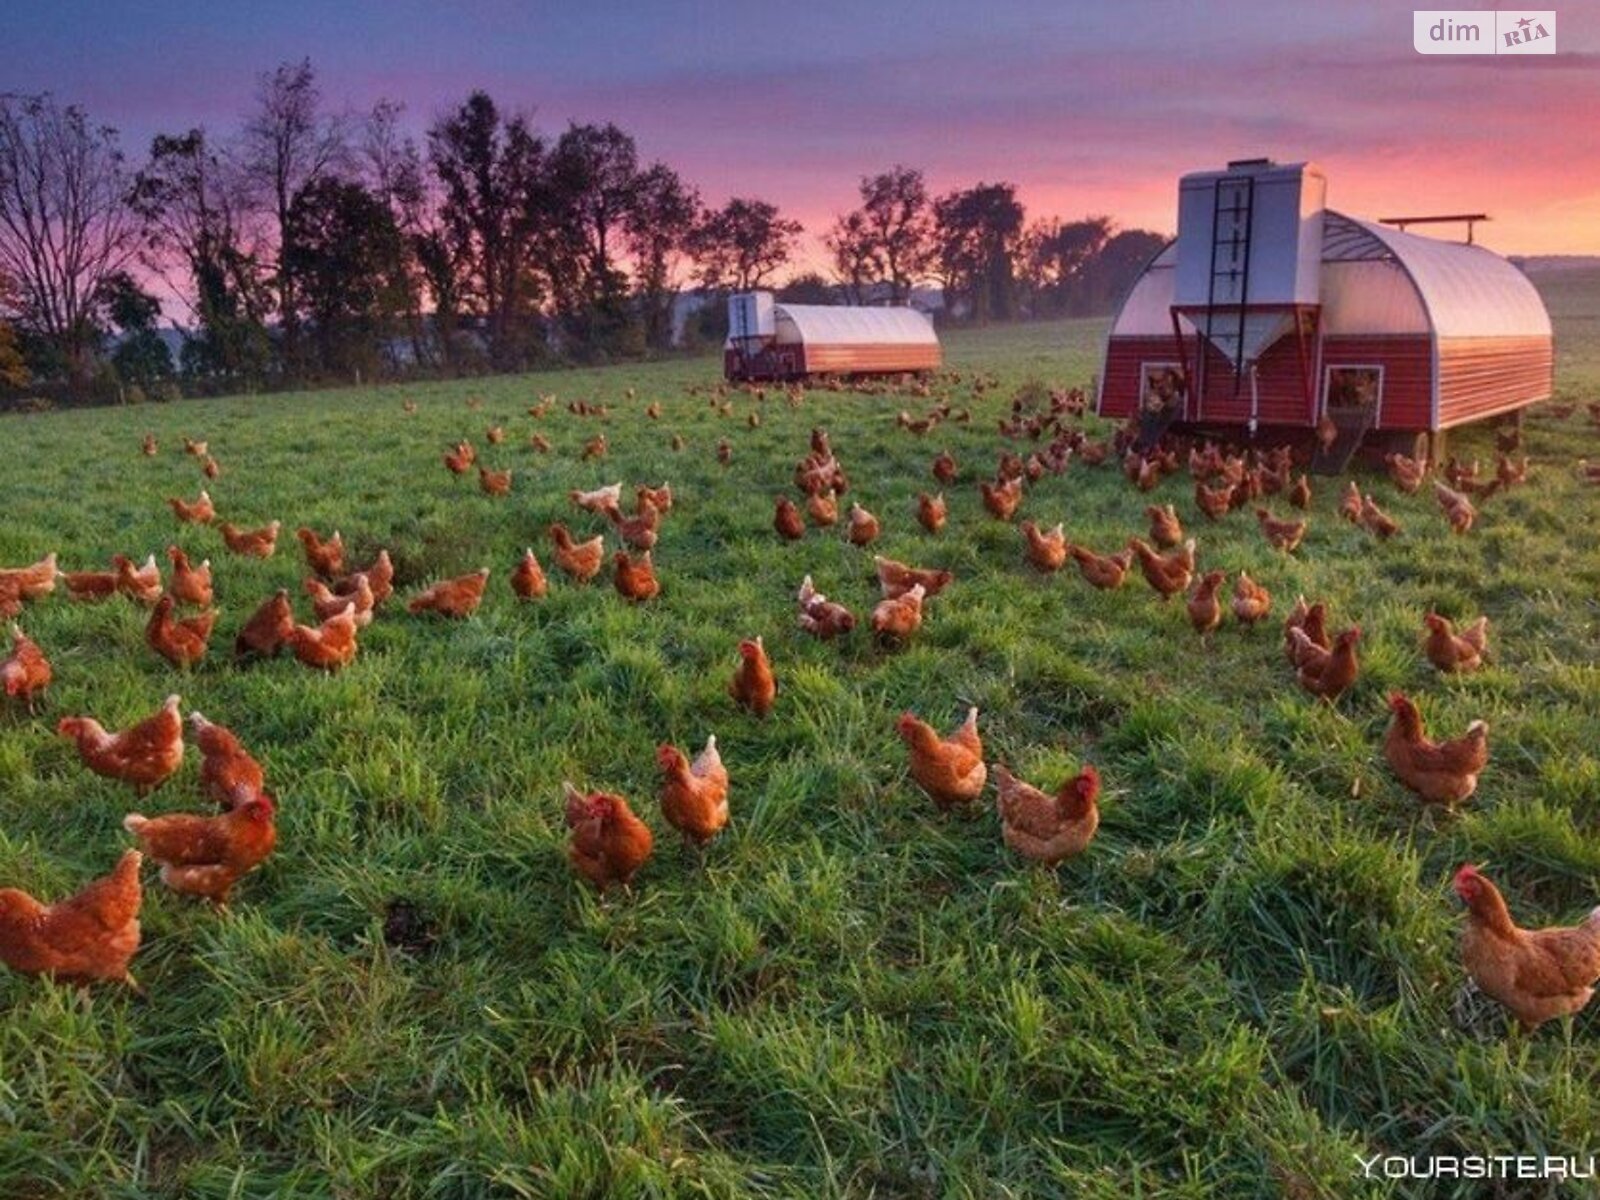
<box><xmin>0</xmin><ymin>850</ymin><xmax>144</xmax><ymax>990</ymax></box>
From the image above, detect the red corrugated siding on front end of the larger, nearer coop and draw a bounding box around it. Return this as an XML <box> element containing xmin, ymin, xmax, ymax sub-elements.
<box><xmin>1101</xmin><ymin>334</ymin><xmax>1432</xmax><ymax>429</ymax></box>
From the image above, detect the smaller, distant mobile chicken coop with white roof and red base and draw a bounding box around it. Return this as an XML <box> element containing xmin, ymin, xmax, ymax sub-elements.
<box><xmin>723</xmin><ymin>291</ymin><xmax>941</xmax><ymax>379</ymax></box>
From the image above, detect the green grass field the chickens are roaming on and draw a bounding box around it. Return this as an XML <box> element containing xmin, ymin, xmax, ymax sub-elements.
<box><xmin>0</xmin><ymin>288</ymin><xmax>1600</xmax><ymax>1200</ymax></box>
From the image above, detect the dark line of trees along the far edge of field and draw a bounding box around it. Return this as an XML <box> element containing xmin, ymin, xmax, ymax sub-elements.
<box><xmin>0</xmin><ymin>59</ymin><xmax>1162</xmax><ymax>397</ymax></box>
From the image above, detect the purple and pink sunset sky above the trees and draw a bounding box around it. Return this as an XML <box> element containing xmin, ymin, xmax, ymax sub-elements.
<box><xmin>15</xmin><ymin>0</ymin><xmax>1600</xmax><ymax>258</ymax></box>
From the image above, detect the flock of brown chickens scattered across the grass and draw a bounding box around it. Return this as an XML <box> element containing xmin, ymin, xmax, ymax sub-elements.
<box><xmin>0</xmin><ymin>386</ymin><xmax>1600</xmax><ymax>1027</ymax></box>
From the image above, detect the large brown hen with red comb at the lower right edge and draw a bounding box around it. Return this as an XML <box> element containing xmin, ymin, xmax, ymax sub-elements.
<box><xmin>1454</xmin><ymin>864</ymin><xmax>1600</xmax><ymax>1029</ymax></box>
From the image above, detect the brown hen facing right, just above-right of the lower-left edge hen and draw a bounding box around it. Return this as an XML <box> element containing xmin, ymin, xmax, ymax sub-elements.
<box><xmin>122</xmin><ymin>792</ymin><xmax>278</xmax><ymax>907</ymax></box>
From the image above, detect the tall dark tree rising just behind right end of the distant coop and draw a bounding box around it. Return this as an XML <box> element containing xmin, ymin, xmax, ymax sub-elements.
<box><xmin>933</xmin><ymin>184</ymin><xmax>1024</xmax><ymax>325</ymax></box>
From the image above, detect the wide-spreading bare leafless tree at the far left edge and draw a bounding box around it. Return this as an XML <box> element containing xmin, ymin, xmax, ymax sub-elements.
<box><xmin>0</xmin><ymin>94</ymin><xmax>138</xmax><ymax>386</ymax></box>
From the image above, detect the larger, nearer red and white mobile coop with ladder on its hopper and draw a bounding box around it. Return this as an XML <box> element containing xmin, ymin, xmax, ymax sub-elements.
<box><xmin>1098</xmin><ymin>158</ymin><xmax>1554</xmax><ymax>470</ymax></box>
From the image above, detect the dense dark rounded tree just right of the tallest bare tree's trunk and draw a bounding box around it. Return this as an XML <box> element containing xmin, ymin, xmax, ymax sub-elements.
<box><xmin>283</xmin><ymin>176</ymin><xmax>406</xmax><ymax>376</ymax></box>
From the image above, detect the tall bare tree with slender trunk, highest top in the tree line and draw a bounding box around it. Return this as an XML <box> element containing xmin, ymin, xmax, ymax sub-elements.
<box><xmin>243</xmin><ymin>58</ymin><xmax>349</xmax><ymax>374</ymax></box>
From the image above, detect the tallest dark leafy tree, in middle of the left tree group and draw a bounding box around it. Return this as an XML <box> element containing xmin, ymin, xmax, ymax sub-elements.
<box><xmin>426</xmin><ymin>91</ymin><xmax>552</xmax><ymax>370</ymax></box>
